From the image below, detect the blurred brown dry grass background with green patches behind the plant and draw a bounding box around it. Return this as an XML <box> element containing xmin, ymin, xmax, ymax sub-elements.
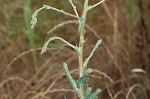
<box><xmin>0</xmin><ymin>0</ymin><xmax>150</xmax><ymax>99</ymax></box>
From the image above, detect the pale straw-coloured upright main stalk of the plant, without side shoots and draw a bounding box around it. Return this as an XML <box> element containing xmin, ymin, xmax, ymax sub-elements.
<box><xmin>79</xmin><ymin>0</ymin><xmax>89</xmax><ymax>99</ymax></box>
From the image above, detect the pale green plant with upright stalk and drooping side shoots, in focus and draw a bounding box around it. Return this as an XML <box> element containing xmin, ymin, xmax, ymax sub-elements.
<box><xmin>31</xmin><ymin>0</ymin><xmax>105</xmax><ymax>99</ymax></box>
